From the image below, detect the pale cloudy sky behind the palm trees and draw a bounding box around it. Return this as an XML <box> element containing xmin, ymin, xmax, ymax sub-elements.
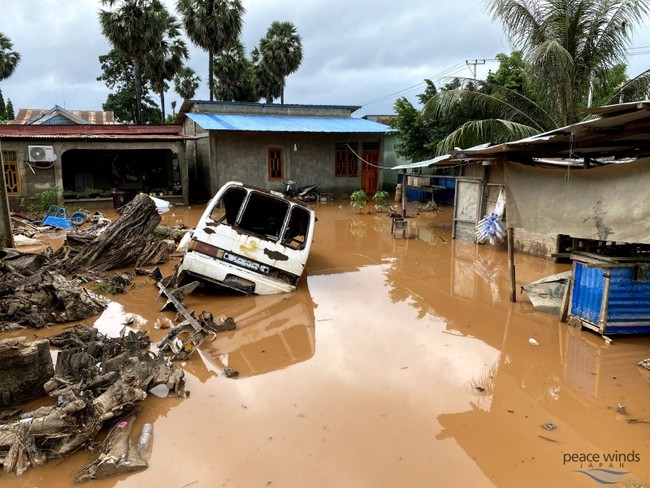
<box><xmin>0</xmin><ymin>0</ymin><xmax>650</xmax><ymax>116</ymax></box>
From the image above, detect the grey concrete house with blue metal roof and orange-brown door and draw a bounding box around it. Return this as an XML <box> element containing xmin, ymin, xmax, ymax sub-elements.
<box><xmin>177</xmin><ymin>100</ymin><xmax>392</xmax><ymax>199</ymax></box>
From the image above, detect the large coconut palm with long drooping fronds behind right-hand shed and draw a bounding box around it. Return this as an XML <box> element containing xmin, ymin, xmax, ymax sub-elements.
<box><xmin>427</xmin><ymin>0</ymin><xmax>650</xmax><ymax>152</ymax></box>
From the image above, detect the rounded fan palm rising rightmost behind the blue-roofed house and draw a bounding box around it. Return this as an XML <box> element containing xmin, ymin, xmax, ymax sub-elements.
<box><xmin>254</xmin><ymin>20</ymin><xmax>302</xmax><ymax>104</ymax></box>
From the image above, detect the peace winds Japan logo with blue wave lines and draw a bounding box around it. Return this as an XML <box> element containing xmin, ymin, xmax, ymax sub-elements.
<box><xmin>563</xmin><ymin>451</ymin><xmax>641</xmax><ymax>485</ymax></box>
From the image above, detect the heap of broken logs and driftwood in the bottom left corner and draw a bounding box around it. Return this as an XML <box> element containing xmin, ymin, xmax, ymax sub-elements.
<box><xmin>0</xmin><ymin>327</ymin><xmax>184</xmax><ymax>481</ymax></box>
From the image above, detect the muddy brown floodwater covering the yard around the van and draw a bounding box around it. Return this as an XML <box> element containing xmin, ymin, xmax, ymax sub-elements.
<box><xmin>0</xmin><ymin>202</ymin><xmax>650</xmax><ymax>488</ymax></box>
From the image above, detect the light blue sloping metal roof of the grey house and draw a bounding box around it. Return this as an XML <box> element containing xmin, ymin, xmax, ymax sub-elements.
<box><xmin>187</xmin><ymin>113</ymin><xmax>393</xmax><ymax>133</ymax></box>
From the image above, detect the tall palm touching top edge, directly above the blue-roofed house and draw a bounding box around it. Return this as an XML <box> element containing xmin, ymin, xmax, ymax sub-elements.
<box><xmin>176</xmin><ymin>0</ymin><xmax>245</xmax><ymax>101</ymax></box>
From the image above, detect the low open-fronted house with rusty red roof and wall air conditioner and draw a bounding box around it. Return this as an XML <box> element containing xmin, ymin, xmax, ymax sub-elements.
<box><xmin>0</xmin><ymin>107</ymin><xmax>188</xmax><ymax>211</ymax></box>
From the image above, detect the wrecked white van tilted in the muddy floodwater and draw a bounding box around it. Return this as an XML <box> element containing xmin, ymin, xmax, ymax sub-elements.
<box><xmin>176</xmin><ymin>181</ymin><xmax>316</xmax><ymax>295</ymax></box>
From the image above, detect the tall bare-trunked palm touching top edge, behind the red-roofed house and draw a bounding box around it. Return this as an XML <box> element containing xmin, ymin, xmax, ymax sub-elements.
<box><xmin>99</xmin><ymin>0</ymin><xmax>169</xmax><ymax>124</ymax></box>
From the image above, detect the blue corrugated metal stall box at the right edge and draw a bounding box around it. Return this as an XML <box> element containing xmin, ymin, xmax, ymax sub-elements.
<box><xmin>570</xmin><ymin>253</ymin><xmax>650</xmax><ymax>335</ymax></box>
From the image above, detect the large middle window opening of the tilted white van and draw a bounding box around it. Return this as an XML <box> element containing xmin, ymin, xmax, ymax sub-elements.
<box><xmin>239</xmin><ymin>192</ymin><xmax>289</xmax><ymax>241</ymax></box>
